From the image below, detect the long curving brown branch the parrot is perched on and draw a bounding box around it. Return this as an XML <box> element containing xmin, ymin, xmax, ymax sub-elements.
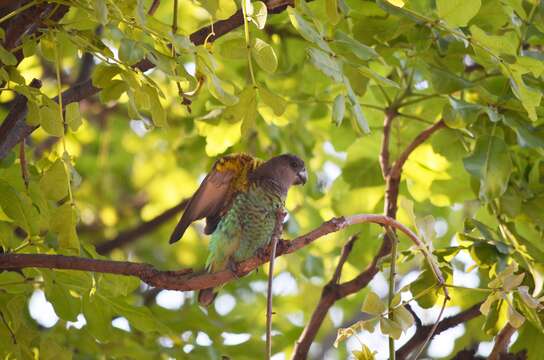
<box><xmin>0</xmin><ymin>214</ymin><xmax>442</xmax><ymax>291</ymax></box>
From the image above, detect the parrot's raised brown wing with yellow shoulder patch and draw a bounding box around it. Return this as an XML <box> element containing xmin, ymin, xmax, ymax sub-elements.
<box><xmin>170</xmin><ymin>154</ymin><xmax>260</xmax><ymax>244</ymax></box>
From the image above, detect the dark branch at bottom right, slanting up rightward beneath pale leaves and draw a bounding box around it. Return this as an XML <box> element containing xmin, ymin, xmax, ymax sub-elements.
<box><xmin>396</xmin><ymin>303</ymin><xmax>481</xmax><ymax>360</ymax></box>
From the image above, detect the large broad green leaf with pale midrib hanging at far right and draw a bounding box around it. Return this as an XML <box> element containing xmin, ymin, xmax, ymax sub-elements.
<box><xmin>463</xmin><ymin>135</ymin><xmax>512</xmax><ymax>201</ymax></box>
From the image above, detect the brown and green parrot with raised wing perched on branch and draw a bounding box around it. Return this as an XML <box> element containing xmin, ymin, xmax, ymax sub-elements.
<box><xmin>170</xmin><ymin>154</ymin><xmax>308</xmax><ymax>306</ymax></box>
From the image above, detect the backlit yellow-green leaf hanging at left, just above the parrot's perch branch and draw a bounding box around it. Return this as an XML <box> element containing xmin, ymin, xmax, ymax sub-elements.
<box><xmin>51</xmin><ymin>202</ymin><xmax>79</xmax><ymax>254</ymax></box>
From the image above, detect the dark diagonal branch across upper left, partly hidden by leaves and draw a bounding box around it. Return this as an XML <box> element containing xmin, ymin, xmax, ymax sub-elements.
<box><xmin>0</xmin><ymin>0</ymin><xmax>293</xmax><ymax>159</ymax></box>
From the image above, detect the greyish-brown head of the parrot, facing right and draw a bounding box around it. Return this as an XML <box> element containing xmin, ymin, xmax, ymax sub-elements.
<box><xmin>252</xmin><ymin>154</ymin><xmax>308</xmax><ymax>193</ymax></box>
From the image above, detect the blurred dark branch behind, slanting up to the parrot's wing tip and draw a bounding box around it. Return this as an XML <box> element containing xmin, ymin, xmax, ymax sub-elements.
<box><xmin>96</xmin><ymin>199</ymin><xmax>188</xmax><ymax>255</ymax></box>
